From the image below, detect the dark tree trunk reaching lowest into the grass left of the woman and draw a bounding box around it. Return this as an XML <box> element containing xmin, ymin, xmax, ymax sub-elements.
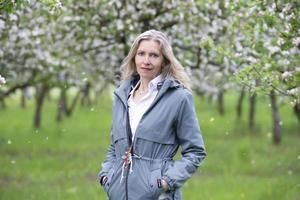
<box><xmin>33</xmin><ymin>84</ymin><xmax>48</xmax><ymax>128</ymax></box>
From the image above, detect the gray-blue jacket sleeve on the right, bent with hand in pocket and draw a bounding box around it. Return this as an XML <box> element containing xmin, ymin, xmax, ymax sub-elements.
<box><xmin>162</xmin><ymin>92</ymin><xmax>206</xmax><ymax>190</ymax></box>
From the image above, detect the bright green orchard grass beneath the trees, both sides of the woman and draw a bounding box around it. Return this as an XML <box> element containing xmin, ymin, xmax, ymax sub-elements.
<box><xmin>0</xmin><ymin>91</ymin><xmax>300</xmax><ymax>200</ymax></box>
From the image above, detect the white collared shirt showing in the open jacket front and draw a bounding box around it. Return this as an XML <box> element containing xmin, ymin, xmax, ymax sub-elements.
<box><xmin>128</xmin><ymin>75</ymin><xmax>162</xmax><ymax>140</ymax></box>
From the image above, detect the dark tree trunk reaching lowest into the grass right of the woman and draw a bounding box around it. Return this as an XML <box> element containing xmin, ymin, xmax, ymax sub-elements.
<box><xmin>270</xmin><ymin>90</ymin><xmax>281</xmax><ymax>144</ymax></box>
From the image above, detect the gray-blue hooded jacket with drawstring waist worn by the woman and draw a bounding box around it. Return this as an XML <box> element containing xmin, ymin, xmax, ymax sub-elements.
<box><xmin>98</xmin><ymin>76</ymin><xmax>206</xmax><ymax>200</ymax></box>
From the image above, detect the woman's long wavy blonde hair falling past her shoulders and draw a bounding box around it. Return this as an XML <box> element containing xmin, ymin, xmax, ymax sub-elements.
<box><xmin>121</xmin><ymin>30</ymin><xmax>191</xmax><ymax>90</ymax></box>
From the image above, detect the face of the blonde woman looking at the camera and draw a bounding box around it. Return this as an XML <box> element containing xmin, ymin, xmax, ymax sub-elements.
<box><xmin>134</xmin><ymin>40</ymin><xmax>164</xmax><ymax>81</ymax></box>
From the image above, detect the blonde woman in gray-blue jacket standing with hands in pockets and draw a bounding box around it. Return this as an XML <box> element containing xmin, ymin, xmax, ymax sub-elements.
<box><xmin>99</xmin><ymin>30</ymin><xmax>206</xmax><ymax>200</ymax></box>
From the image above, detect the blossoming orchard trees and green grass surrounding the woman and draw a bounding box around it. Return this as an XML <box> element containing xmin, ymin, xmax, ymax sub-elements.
<box><xmin>0</xmin><ymin>0</ymin><xmax>300</xmax><ymax>200</ymax></box>
